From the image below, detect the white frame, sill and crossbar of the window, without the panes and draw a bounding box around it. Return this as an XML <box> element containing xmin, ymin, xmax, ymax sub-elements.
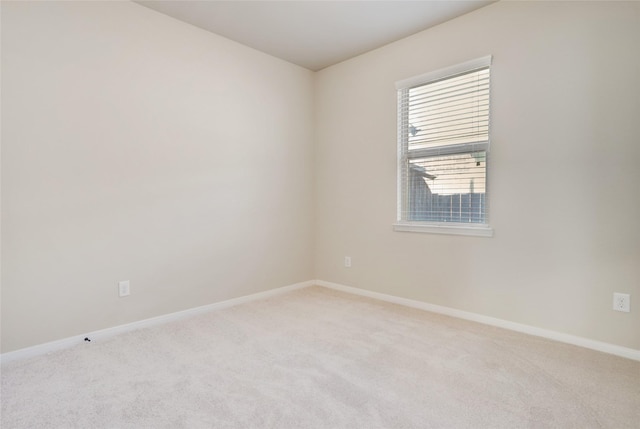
<box><xmin>393</xmin><ymin>55</ymin><xmax>493</xmax><ymax>237</ymax></box>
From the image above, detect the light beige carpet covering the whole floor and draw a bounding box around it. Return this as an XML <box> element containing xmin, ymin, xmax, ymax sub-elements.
<box><xmin>1</xmin><ymin>287</ymin><xmax>640</xmax><ymax>429</ymax></box>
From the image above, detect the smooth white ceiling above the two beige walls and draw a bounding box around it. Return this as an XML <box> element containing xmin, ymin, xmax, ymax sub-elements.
<box><xmin>136</xmin><ymin>0</ymin><xmax>493</xmax><ymax>71</ymax></box>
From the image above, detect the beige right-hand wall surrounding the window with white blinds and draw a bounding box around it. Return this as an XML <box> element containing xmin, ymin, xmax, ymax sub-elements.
<box><xmin>316</xmin><ymin>2</ymin><xmax>640</xmax><ymax>349</ymax></box>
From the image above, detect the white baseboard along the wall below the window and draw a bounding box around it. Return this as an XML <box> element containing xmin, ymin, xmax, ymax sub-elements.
<box><xmin>314</xmin><ymin>280</ymin><xmax>640</xmax><ymax>361</ymax></box>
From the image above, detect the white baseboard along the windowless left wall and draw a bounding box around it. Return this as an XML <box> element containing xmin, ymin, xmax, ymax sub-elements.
<box><xmin>0</xmin><ymin>280</ymin><xmax>315</xmax><ymax>364</ymax></box>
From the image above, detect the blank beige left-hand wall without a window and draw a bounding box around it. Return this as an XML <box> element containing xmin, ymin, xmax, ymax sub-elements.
<box><xmin>2</xmin><ymin>2</ymin><xmax>313</xmax><ymax>352</ymax></box>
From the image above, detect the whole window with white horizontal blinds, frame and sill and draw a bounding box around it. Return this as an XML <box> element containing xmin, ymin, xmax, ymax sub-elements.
<box><xmin>394</xmin><ymin>56</ymin><xmax>492</xmax><ymax>236</ymax></box>
